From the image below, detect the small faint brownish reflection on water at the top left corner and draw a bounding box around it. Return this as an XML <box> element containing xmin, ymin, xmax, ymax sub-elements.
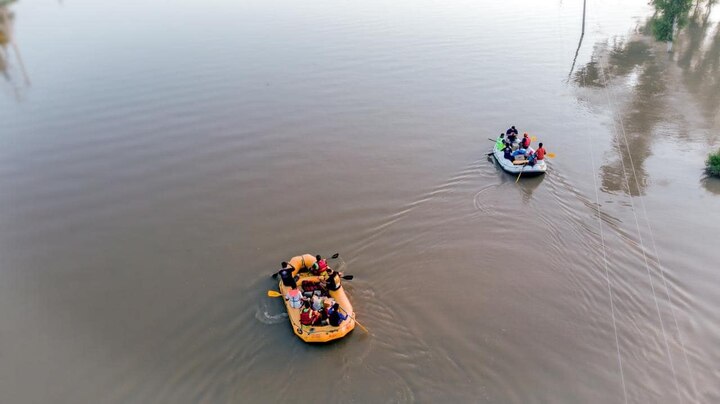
<box><xmin>0</xmin><ymin>0</ymin><xmax>30</xmax><ymax>98</ymax></box>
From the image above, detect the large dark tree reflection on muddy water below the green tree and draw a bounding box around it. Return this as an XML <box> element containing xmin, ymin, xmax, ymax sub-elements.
<box><xmin>574</xmin><ymin>2</ymin><xmax>720</xmax><ymax>196</ymax></box>
